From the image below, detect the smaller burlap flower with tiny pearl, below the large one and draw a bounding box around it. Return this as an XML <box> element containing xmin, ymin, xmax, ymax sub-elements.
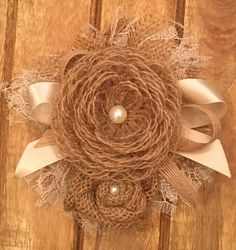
<box><xmin>64</xmin><ymin>169</ymin><xmax>158</xmax><ymax>227</ymax></box>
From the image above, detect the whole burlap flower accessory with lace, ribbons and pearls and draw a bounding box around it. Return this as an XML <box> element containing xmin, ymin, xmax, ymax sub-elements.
<box><xmin>3</xmin><ymin>14</ymin><xmax>230</xmax><ymax>227</ymax></box>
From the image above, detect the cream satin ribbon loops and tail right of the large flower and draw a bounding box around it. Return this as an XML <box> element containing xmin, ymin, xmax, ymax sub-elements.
<box><xmin>177</xmin><ymin>79</ymin><xmax>231</xmax><ymax>177</ymax></box>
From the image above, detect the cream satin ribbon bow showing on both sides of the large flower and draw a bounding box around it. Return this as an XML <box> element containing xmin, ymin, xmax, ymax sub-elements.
<box><xmin>16</xmin><ymin>79</ymin><xmax>231</xmax><ymax>177</ymax></box>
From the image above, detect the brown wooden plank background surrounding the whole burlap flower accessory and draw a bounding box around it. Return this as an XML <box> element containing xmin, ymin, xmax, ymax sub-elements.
<box><xmin>0</xmin><ymin>0</ymin><xmax>236</xmax><ymax>250</ymax></box>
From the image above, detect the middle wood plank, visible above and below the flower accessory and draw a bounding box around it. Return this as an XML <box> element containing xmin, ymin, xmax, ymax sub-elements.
<box><xmin>83</xmin><ymin>0</ymin><xmax>181</xmax><ymax>250</ymax></box>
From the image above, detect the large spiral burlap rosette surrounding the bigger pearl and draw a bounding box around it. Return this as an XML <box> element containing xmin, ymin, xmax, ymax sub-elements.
<box><xmin>53</xmin><ymin>47</ymin><xmax>181</xmax><ymax>180</ymax></box>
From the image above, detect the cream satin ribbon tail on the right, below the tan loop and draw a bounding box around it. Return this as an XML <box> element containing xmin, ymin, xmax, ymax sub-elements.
<box><xmin>177</xmin><ymin>129</ymin><xmax>231</xmax><ymax>177</ymax></box>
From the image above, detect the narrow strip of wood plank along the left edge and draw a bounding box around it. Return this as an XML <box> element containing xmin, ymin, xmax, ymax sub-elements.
<box><xmin>0</xmin><ymin>0</ymin><xmax>17</xmax><ymax>249</ymax></box>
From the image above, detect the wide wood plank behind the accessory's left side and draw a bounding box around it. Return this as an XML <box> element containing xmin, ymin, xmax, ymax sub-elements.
<box><xmin>0</xmin><ymin>0</ymin><xmax>90</xmax><ymax>250</ymax></box>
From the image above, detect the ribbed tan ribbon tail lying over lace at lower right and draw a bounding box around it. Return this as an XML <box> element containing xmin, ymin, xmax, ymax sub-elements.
<box><xmin>160</xmin><ymin>162</ymin><xmax>197</xmax><ymax>206</ymax></box>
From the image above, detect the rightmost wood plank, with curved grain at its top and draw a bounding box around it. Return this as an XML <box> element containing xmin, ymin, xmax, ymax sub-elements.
<box><xmin>170</xmin><ymin>0</ymin><xmax>236</xmax><ymax>250</ymax></box>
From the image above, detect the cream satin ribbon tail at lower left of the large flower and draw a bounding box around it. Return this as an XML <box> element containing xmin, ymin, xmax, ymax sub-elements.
<box><xmin>15</xmin><ymin>140</ymin><xmax>63</xmax><ymax>177</ymax></box>
